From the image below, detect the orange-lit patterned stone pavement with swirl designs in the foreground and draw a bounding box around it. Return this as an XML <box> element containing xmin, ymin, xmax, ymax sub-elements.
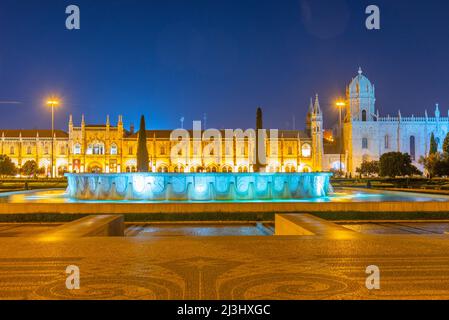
<box><xmin>0</xmin><ymin>235</ymin><xmax>449</xmax><ymax>300</ymax></box>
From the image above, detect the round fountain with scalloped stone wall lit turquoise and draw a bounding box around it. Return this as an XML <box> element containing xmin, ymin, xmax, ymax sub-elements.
<box><xmin>66</xmin><ymin>173</ymin><xmax>332</xmax><ymax>201</ymax></box>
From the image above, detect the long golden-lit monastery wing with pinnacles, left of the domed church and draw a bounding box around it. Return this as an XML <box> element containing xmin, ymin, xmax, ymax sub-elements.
<box><xmin>0</xmin><ymin>109</ymin><xmax>323</xmax><ymax>176</ymax></box>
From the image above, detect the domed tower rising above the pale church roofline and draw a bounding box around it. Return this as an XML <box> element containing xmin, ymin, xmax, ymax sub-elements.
<box><xmin>346</xmin><ymin>68</ymin><xmax>376</xmax><ymax>121</ymax></box>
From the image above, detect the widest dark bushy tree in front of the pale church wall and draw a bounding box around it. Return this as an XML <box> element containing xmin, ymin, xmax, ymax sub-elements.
<box><xmin>379</xmin><ymin>152</ymin><xmax>422</xmax><ymax>178</ymax></box>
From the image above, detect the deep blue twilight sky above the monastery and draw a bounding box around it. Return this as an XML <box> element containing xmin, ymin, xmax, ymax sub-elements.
<box><xmin>0</xmin><ymin>0</ymin><xmax>449</xmax><ymax>129</ymax></box>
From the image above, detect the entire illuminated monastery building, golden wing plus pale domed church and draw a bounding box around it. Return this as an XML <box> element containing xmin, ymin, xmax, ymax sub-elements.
<box><xmin>6</xmin><ymin>69</ymin><xmax>430</xmax><ymax>175</ymax></box>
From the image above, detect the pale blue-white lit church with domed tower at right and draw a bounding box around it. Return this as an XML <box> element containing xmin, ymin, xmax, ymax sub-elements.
<box><xmin>343</xmin><ymin>69</ymin><xmax>449</xmax><ymax>175</ymax></box>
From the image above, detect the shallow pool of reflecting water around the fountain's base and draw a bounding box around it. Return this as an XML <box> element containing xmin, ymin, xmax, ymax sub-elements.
<box><xmin>0</xmin><ymin>189</ymin><xmax>449</xmax><ymax>204</ymax></box>
